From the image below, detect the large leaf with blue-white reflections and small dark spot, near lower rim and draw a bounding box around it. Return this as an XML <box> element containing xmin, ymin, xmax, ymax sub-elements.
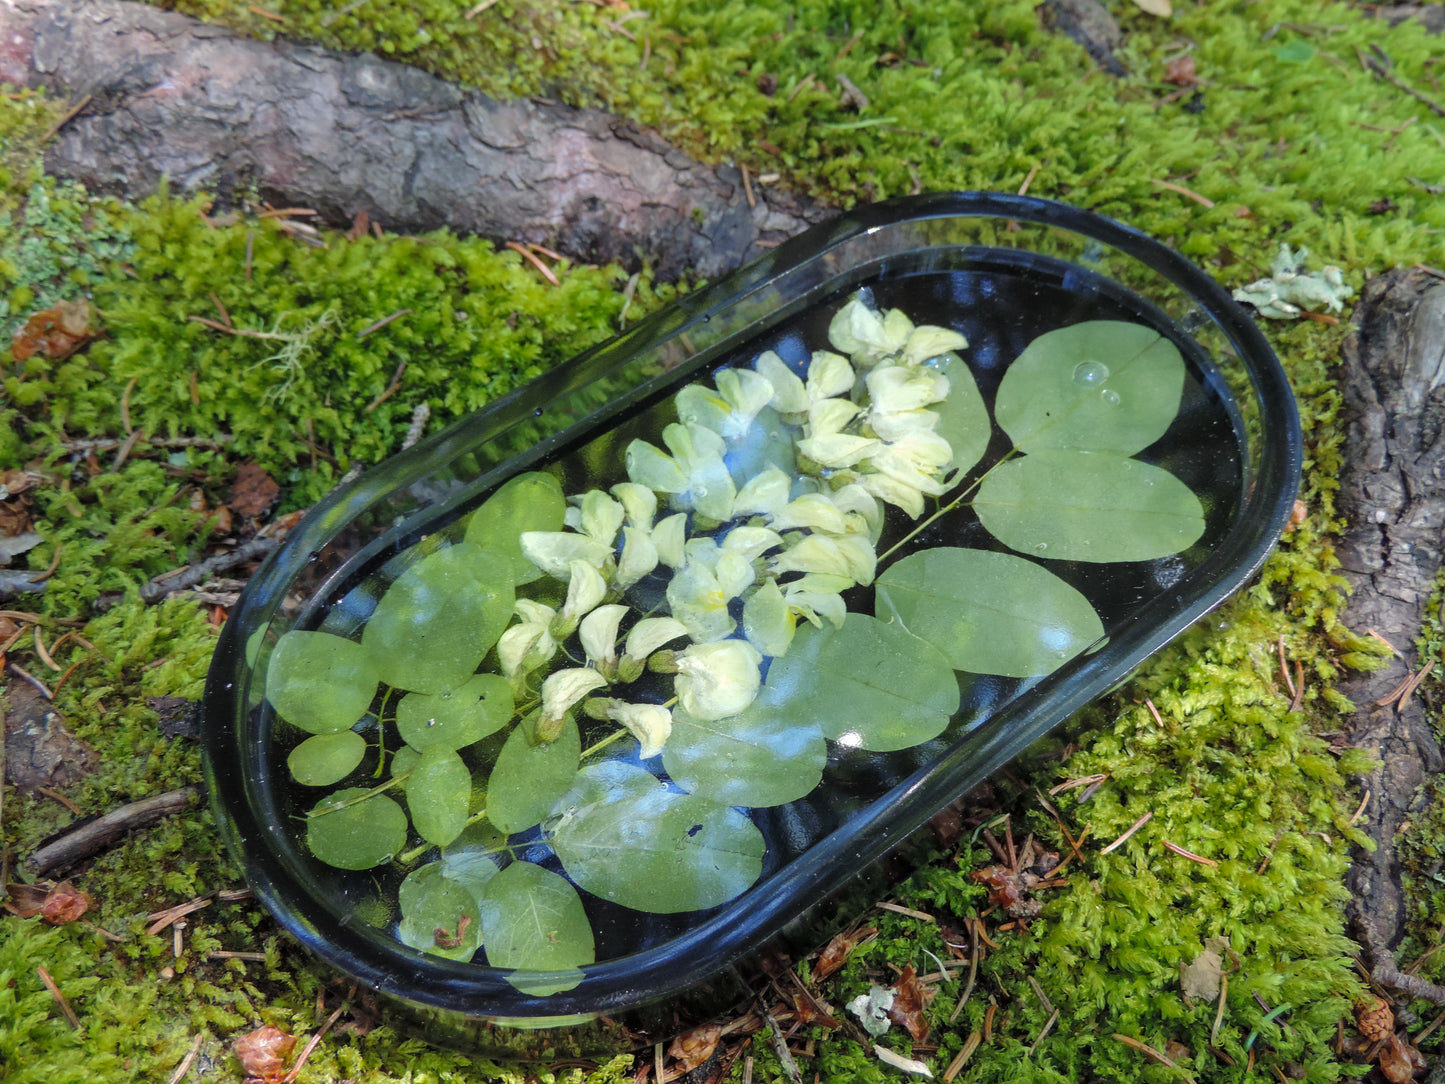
<box><xmin>552</xmin><ymin>763</ymin><xmax>766</xmax><ymax>915</ymax></box>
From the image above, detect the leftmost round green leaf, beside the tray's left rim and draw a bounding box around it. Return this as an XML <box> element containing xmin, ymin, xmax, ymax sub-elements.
<box><xmin>266</xmin><ymin>629</ymin><xmax>379</xmax><ymax>734</ymax></box>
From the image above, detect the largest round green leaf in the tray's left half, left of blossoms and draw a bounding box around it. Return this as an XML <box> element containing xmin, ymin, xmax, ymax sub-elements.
<box><xmin>353</xmin><ymin>542</ymin><xmax>514</xmax><ymax>696</ymax></box>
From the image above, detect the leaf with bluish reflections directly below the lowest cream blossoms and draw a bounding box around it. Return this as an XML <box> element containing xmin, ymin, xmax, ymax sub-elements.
<box><xmin>662</xmin><ymin>690</ymin><xmax>826</xmax><ymax>806</ymax></box>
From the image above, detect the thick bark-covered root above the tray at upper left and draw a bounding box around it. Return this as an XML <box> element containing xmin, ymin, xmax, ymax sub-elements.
<box><xmin>0</xmin><ymin>0</ymin><xmax>831</xmax><ymax>279</ymax></box>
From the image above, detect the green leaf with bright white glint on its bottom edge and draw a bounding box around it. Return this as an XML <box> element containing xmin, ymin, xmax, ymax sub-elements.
<box><xmin>764</xmin><ymin>613</ymin><xmax>959</xmax><ymax>753</ymax></box>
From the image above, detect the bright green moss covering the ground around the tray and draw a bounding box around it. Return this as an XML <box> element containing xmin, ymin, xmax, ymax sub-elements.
<box><xmin>0</xmin><ymin>0</ymin><xmax>1445</xmax><ymax>1084</ymax></box>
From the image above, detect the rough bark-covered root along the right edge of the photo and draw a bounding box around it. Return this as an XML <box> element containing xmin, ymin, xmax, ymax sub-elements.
<box><xmin>1340</xmin><ymin>269</ymin><xmax>1445</xmax><ymax>981</ymax></box>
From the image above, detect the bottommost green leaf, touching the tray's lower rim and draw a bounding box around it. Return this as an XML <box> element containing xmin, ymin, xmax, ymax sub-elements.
<box><xmin>481</xmin><ymin>861</ymin><xmax>597</xmax><ymax>996</ymax></box>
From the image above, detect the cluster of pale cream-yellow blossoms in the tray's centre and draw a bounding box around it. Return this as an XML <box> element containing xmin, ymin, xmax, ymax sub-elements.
<box><xmin>497</xmin><ymin>298</ymin><xmax>967</xmax><ymax>757</ymax></box>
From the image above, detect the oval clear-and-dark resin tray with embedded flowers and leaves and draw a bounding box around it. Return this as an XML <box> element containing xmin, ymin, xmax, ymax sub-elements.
<box><xmin>204</xmin><ymin>194</ymin><xmax>1301</xmax><ymax>1026</ymax></box>
